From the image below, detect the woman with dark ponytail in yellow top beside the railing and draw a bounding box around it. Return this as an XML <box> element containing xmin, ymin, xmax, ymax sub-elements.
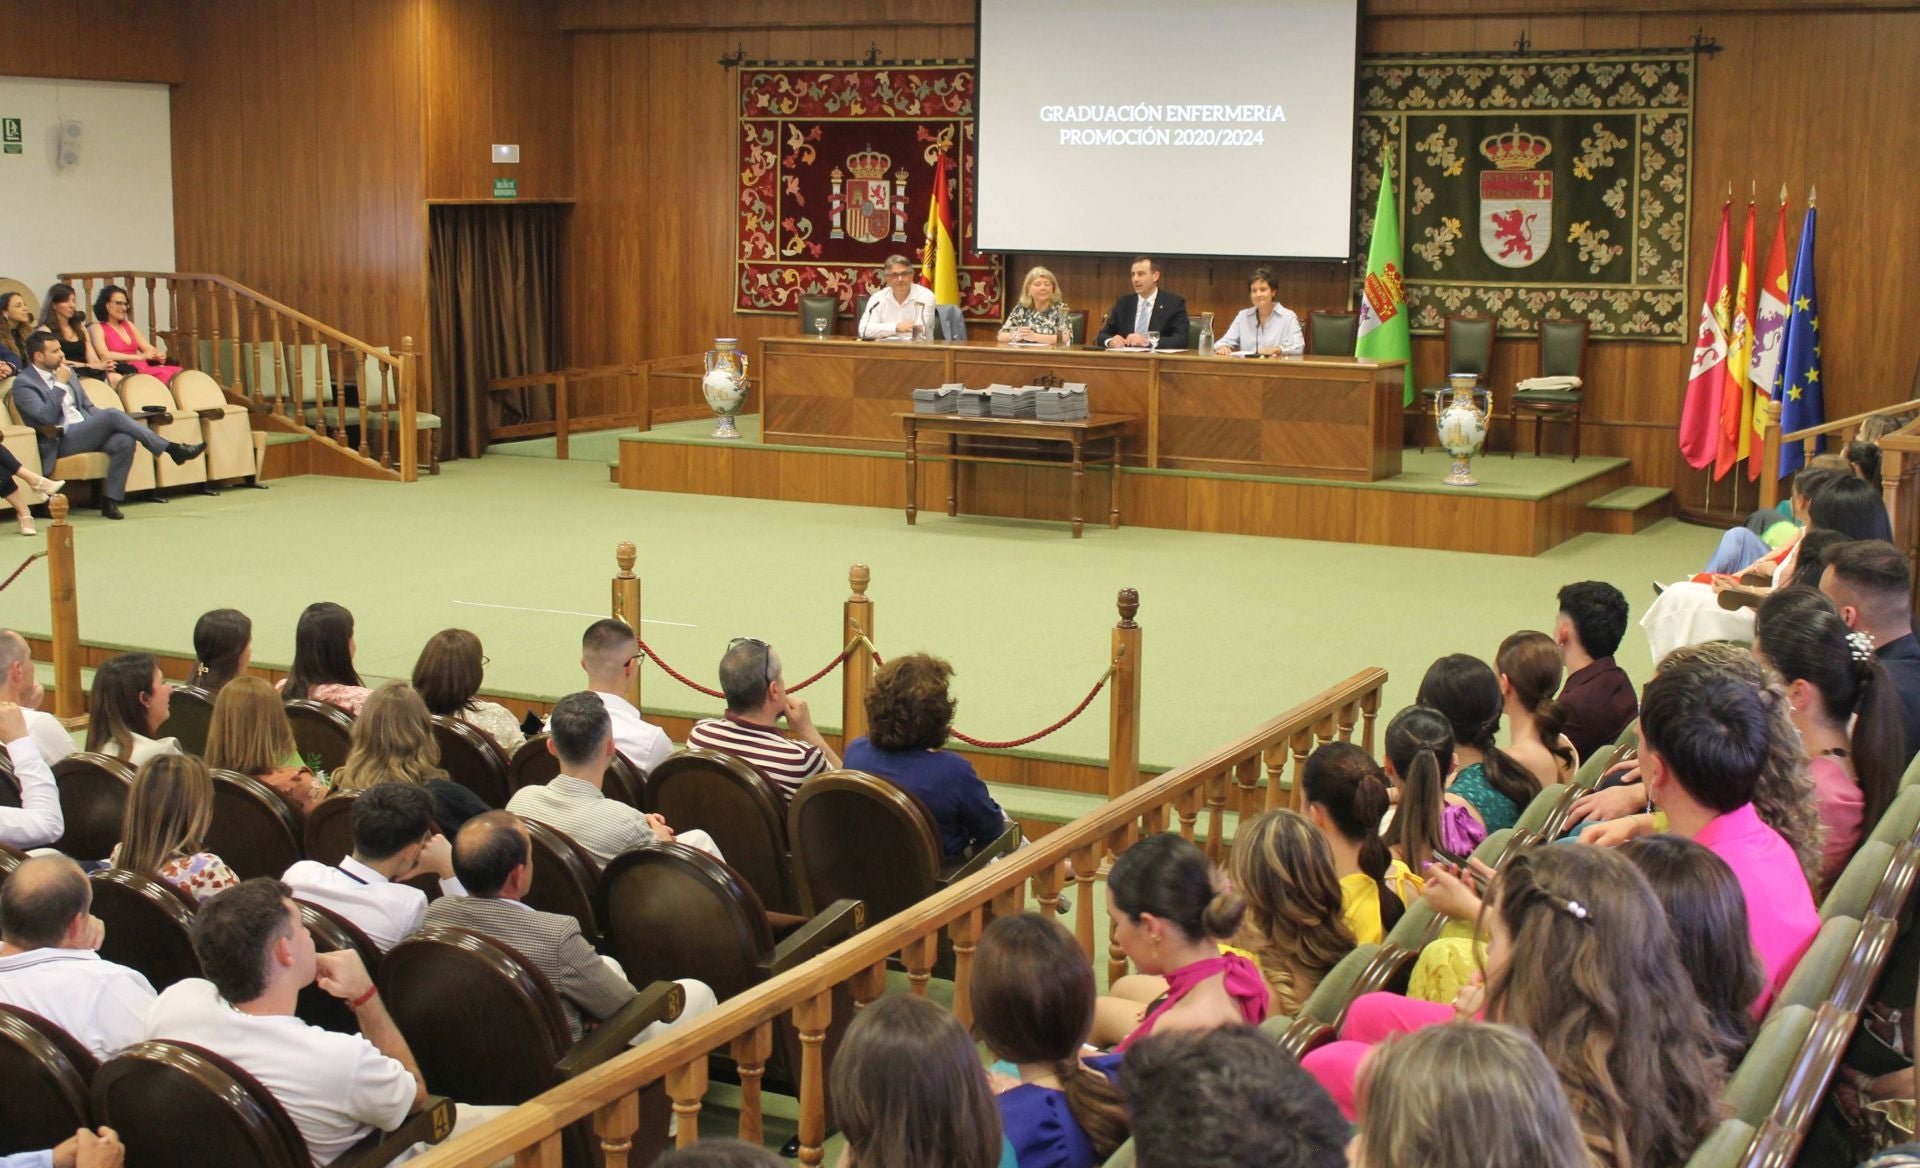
<box><xmin>1305</xmin><ymin>742</ymin><xmax>1419</xmax><ymax>945</ymax></box>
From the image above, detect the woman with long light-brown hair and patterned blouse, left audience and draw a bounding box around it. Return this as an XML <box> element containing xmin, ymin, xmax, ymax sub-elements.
<box><xmin>108</xmin><ymin>755</ymin><xmax>240</xmax><ymax>903</ymax></box>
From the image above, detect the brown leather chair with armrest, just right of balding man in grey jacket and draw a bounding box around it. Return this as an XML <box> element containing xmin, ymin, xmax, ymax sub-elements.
<box><xmin>597</xmin><ymin>843</ymin><xmax>866</xmax><ymax>1085</ymax></box>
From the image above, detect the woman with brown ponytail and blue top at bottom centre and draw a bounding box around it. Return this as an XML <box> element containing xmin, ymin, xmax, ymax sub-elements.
<box><xmin>968</xmin><ymin>913</ymin><xmax>1127</xmax><ymax>1168</ymax></box>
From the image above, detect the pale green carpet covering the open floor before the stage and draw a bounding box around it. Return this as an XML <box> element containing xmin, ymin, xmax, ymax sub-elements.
<box><xmin>0</xmin><ymin>457</ymin><xmax>1716</xmax><ymax>767</ymax></box>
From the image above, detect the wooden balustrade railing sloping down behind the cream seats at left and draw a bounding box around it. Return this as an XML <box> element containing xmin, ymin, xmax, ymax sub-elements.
<box><xmin>60</xmin><ymin>271</ymin><xmax>422</xmax><ymax>482</ymax></box>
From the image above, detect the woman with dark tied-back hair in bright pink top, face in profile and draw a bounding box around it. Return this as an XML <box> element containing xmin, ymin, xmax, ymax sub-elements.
<box><xmin>1094</xmin><ymin>832</ymin><xmax>1267</xmax><ymax>1051</ymax></box>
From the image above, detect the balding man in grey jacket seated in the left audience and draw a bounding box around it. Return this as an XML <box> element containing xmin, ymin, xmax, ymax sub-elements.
<box><xmin>426</xmin><ymin>811</ymin><xmax>716</xmax><ymax>1045</ymax></box>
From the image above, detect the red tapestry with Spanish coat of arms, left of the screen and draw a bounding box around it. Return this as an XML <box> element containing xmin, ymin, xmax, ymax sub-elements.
<box><xmin>735</xmin><ymin>61</ymin><xmax>1006</xmax><ymax>321</ymax></box>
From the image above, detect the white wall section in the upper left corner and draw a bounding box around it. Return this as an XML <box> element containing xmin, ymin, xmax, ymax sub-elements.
<box><xmin>0</xmin><ymin>77</ymin><xmax>173</xmax><ymax>317</ymax></box>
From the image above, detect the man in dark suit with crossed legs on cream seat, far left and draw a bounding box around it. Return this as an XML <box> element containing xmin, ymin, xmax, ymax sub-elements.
<box><xmin>13</xmin><ymin>332</ymin><xmax>207</xmax><ymax>519</ymax></box>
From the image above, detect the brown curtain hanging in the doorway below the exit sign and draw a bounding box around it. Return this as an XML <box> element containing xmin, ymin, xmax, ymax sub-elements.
<box><xmin>428</xmin><ymin>204</ymin><xmax>566</xmax><ymax>459</ymax></box>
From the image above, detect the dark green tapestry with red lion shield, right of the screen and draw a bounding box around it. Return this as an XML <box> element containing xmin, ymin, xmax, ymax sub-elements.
<box><xmin>1354</xmin><ymin>52</ymin><xmax>1693</xmax><ymax>342</ymax></box>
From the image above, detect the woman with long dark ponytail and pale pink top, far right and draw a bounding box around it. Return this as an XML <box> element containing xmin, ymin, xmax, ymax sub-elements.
<box><xmin>1753</xmin><ymin>588</ymin><xmax>1905</xmax><ymax>884</ymax></box>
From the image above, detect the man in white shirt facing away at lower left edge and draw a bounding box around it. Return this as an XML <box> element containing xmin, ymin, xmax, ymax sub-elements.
<box><xmin>0</xmin><ymin>855</ymin><xmax>154</xmax><ymax>1062</ymax></box>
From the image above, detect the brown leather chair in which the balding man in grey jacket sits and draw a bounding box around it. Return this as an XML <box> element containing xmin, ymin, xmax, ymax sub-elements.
<box><xmin>380</xmin><ymin>926</ymin><xmax>685</xmax><ymax>1164</ymax></box>
